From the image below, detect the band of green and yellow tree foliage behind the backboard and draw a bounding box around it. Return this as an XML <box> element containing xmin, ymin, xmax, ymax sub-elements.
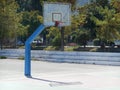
<box><xmin>0</xmin><ymin>0</ymin><xmax>120</xmax><ymax>50</ymax></box>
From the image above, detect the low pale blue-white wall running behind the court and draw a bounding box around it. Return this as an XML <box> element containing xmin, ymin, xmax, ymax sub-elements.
<box><xmin>0</xmin><ymin>49</ymin><xmax>120</xmax><ymax>66</ymax></box>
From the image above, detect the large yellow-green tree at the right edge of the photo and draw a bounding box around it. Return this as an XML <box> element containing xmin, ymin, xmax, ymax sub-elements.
<box><xmin>91</xmin><ymin>7</ymin><xmax>120</xmax><ymax>45</ymax></box>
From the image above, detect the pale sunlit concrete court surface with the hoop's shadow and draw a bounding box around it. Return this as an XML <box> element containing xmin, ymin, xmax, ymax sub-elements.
<box><xmin>0</xmin><ymin>59</ymin><xmax>120</xmax><ymax>90</ymax></box>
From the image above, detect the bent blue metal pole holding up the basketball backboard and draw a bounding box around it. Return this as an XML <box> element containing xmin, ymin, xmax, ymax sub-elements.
<box><xmin>24</xmin><ymin>24</ymin><xmax>45</xmax><ymax>77</ymax></box>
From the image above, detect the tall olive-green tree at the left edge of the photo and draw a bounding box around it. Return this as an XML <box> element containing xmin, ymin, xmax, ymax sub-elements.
<box><xmin>0</xmin><ymin>0</ymin><xmax>25</xmax><ymax>48</ymax></box>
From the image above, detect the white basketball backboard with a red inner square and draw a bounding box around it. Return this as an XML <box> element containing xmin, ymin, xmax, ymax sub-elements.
<box><xmin>43</xmin><ymin>2</ymin><xmax>71</xmax><ymax>26</ymax></box>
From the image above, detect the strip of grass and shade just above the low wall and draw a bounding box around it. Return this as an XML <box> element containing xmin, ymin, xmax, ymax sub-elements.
<box><xmin>27</xmin><ymin>46</ymin><xmax>120</xmax><ymax>52</ymax></box>
